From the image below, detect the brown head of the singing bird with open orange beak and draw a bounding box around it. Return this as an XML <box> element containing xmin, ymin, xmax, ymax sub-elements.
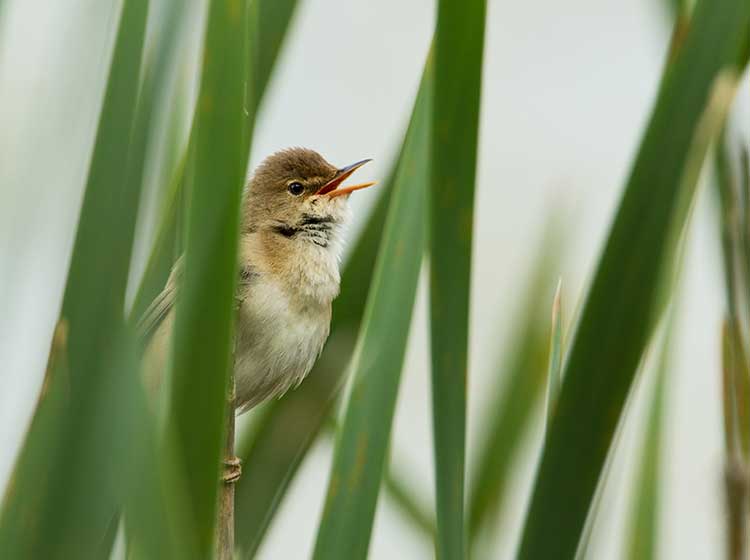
<box><xmin>243</xmin><ymin>148</ymin><xmax>375</xmax><ymax>246</ymax></box>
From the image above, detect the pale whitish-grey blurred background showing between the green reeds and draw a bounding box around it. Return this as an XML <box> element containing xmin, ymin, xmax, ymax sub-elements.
<box><xmin>0</xmin><ymin>0</ymin><xmax>750</xmax><ymax>559</ymax></box>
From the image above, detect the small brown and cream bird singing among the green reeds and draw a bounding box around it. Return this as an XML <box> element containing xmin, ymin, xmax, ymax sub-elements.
<box><xmin>138</xmin><ymin>148</ymin><xmax>375</xmax><ymax>414</ymax></box>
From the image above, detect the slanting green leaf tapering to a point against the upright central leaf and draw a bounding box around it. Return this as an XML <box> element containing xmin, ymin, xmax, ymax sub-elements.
<box><xmin>313</xmin><ymin>60</ymin><xmax>432</xmax><ymax>560</ymax></box>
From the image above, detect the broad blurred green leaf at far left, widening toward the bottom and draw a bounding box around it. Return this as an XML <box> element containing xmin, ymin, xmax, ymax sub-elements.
<box><xmin>0</xmin><ymin>0</ymin><xmax>148</xmax><ymax>558</ymax></box>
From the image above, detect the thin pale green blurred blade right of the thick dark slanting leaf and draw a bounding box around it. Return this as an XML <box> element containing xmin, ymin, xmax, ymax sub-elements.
<box><xmin>624</xmin><ymin>332</ymin><xmax>674</xmax><ymax>560</ymax></box>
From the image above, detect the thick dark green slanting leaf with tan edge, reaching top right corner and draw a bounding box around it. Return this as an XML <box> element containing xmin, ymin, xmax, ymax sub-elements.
<box><xmin>519</xmin><ymin>0</ymin><xmax>750</xmax><ymax>559</ymax></box>
